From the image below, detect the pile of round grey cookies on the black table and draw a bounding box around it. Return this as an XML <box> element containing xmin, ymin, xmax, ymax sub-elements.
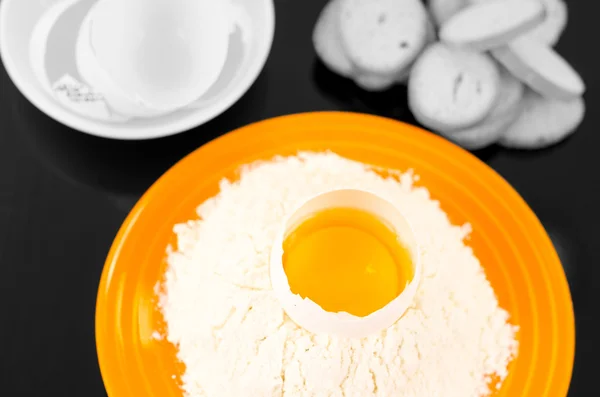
<box><xmin>313</xmin><ymin>0</ymin><xmax>585</xmax><ymax>150</ymax></box>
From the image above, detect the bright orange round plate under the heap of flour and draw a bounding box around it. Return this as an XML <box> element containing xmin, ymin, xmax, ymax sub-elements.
<box><xmin>96</xmin><ymin>113</ymin><xmax>575</xmax><ymax>397</ymax></box>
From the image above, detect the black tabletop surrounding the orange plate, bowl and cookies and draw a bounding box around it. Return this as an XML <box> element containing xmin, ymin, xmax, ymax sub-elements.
<box><xmin>0</xmin><ymin>0</ymin><xmax>600</xmax><ymax>397</ymax></box>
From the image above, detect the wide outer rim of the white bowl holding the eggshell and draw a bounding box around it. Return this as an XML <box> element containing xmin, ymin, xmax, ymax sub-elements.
<box><xmin>0</xmin><ymin>0</ymin><xmax>275</xmax><ymax>140</ymax></box>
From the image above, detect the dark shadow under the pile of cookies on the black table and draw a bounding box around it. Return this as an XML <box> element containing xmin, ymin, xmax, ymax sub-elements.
<box><xmin>313</xmin><ymin>60</ymin><xmax>500</xmax><ymax>162</ymax></box>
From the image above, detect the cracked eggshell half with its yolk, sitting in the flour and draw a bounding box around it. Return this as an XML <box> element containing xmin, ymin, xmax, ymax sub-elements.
<box><xmin>270</xmin><ymin>189</ymin><xmax>420</xmax><ymax>338</ymax></box>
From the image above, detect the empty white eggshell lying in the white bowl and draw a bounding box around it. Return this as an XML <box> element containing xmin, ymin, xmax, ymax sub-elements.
<box><xmin>90</xmin><ymin>0</ymin><xmax>231</xmax><ymax>111</ymax></box>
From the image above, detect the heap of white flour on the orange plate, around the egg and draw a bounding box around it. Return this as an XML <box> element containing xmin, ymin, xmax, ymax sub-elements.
<box><xmin>160</xmin><ymin>153</ymin><xmax>517</xmax><ymax>397</ymax></box>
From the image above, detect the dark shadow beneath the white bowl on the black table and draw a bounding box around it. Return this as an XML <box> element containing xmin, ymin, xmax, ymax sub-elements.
<box><xmin>12</xmin><ymin>71</ymin><xmax>266</xmax><ymax>211</ymax></box>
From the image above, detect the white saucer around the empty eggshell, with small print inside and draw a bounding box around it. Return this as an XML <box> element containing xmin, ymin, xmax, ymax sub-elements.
<box><xmin>0</xmin><ymin>0</ymin><xmax>275</xmax><ymax>140</ymax></box>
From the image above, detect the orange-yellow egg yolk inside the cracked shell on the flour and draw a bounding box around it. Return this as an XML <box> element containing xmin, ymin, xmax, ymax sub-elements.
<box><xmin>283</xmin><ymin>208</ymin><xmax>413</xmax><ymax>317</ymax></box>
